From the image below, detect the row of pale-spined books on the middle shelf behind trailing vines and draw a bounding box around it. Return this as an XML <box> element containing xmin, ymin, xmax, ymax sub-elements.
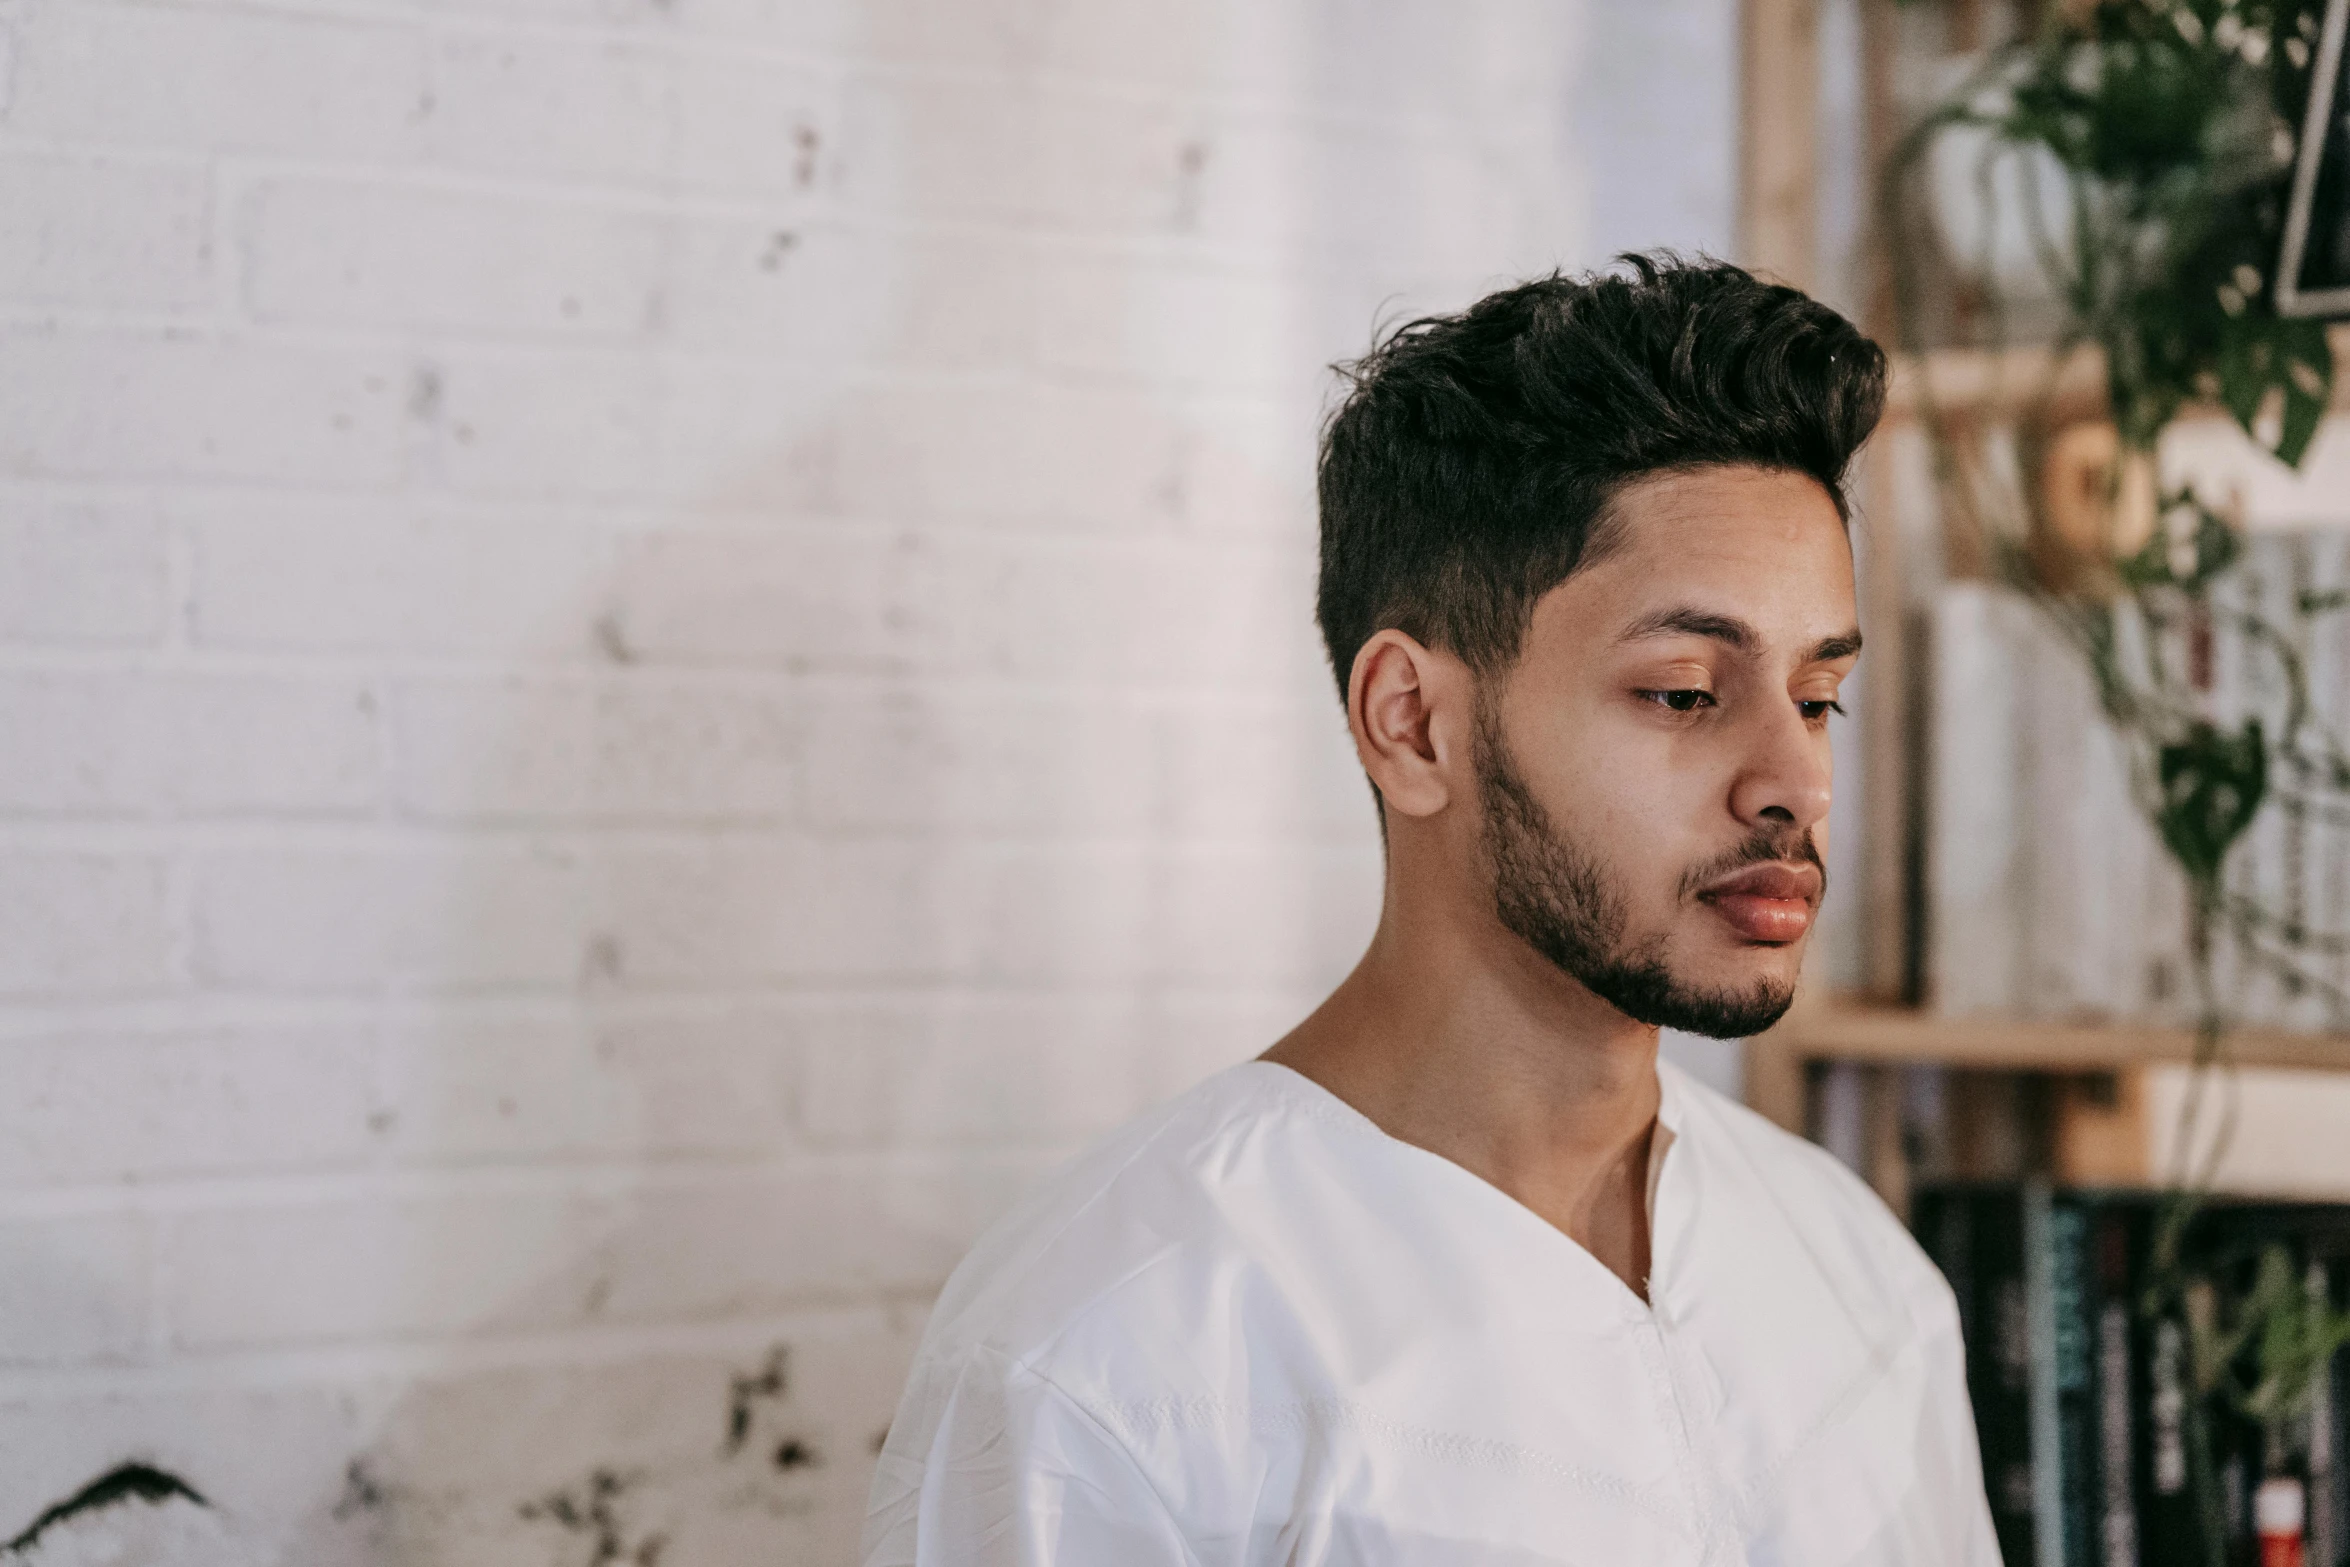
<box><xmin>1925</xmin><ymin>529</ymin><xmax>2350</xmax><ymax>1029</ymax></box>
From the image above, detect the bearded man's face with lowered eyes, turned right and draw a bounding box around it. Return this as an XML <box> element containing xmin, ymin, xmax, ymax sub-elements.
<box><xmin>1476</xmin><ymin>468</ymin><xmax>1859</xmax><ymax>1038</ymax></box>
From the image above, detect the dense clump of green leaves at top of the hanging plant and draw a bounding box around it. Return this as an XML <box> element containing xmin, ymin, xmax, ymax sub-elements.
<box><xmin>1889</xmin><ymin>0</ymin><xmax>2334</xmax><ymax>468</ymax></box>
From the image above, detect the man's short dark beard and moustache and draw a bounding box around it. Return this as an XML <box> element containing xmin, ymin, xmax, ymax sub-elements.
<box><xmin>1476</xmin><ymin>702</ymin><xmax>1819</xmax><ymax>1038</ymax></box>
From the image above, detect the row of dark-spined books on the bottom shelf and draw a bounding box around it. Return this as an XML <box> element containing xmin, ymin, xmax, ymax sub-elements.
<box><xmin>1913</xmin><ymin>1182</ymin><xmax>2350</xmax><ymax>1567</ymax></box>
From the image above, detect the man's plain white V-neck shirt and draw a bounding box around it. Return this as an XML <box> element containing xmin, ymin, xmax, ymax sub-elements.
<box><xmin>865</xmin><ymin>1062</ymin><xmax>1998</xmax><ymax>1567</ymax></box>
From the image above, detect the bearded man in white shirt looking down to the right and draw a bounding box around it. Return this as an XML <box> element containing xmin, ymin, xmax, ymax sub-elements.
<box><xmin>867</xmin><ymin>258</ymin><xmax>1998</xmax><ymax>1567</ymax></box>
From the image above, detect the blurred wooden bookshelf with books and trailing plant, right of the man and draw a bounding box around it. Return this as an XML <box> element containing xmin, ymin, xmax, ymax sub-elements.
<box><xmin>1748</xmin><ymin>0</ymin><xmax>2350</xmax><ymax>1567</ymax></box>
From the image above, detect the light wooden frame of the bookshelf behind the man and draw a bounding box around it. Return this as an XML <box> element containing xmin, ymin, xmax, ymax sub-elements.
<box><xmin>1739</xmin><ymin>0</ymin><xmax>2350</xmax><ymax>1208</ymax></box>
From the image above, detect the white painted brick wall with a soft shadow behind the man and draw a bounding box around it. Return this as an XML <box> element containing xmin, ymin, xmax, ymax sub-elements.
<box><xmin>0</xmin><ymin>0</ymin><xmax>1727</xmax><ymax>1567</ymax></box>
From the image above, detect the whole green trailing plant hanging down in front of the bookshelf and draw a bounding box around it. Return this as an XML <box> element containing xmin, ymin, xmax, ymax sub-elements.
<box><xmin>1882</xmin><ymin>0</ymin><xmax>2350</xmax><ymax>1565</ymax></box>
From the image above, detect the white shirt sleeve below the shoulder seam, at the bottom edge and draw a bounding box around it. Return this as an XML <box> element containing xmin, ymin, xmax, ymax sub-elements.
<box><xmin>865</xmin><ymin>1353</ymin><xmax>1196</xmax><ymax>1567</ymax></box>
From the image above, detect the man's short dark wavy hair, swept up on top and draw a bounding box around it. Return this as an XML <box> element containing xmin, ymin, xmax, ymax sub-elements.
<box><xmin>1316</xmin><ymin>251</ymin><xmax>1885</xmax><ymax>695</ymax></box>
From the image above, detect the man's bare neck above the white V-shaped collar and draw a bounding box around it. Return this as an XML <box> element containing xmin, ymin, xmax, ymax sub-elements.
<box><xmin>1264</xmin><ymin>909</ymin><xmax>1659</xmax><ymax>1299</ymax></box>
